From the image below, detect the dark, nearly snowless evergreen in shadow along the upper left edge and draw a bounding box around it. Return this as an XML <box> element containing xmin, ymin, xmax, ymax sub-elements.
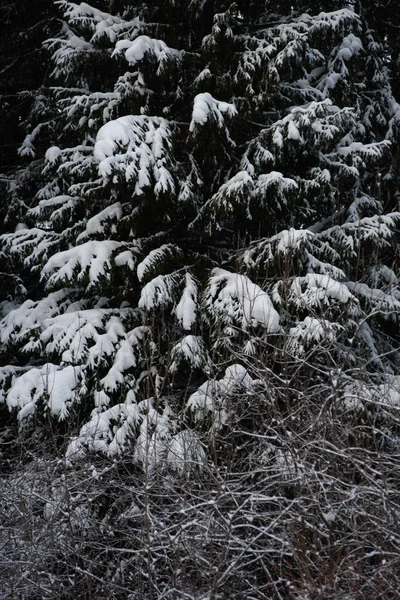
<box><xmin>0</xmin><ymin>0</ymin><xmax>59</xmax><ymax>310</ymax></box>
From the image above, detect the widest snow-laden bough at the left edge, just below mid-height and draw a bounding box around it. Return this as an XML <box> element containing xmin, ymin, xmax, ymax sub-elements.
<box><xmin>0</xmin><ymin>298</ymin><xmax>148</xmax><ymax>400</ymax></box>
